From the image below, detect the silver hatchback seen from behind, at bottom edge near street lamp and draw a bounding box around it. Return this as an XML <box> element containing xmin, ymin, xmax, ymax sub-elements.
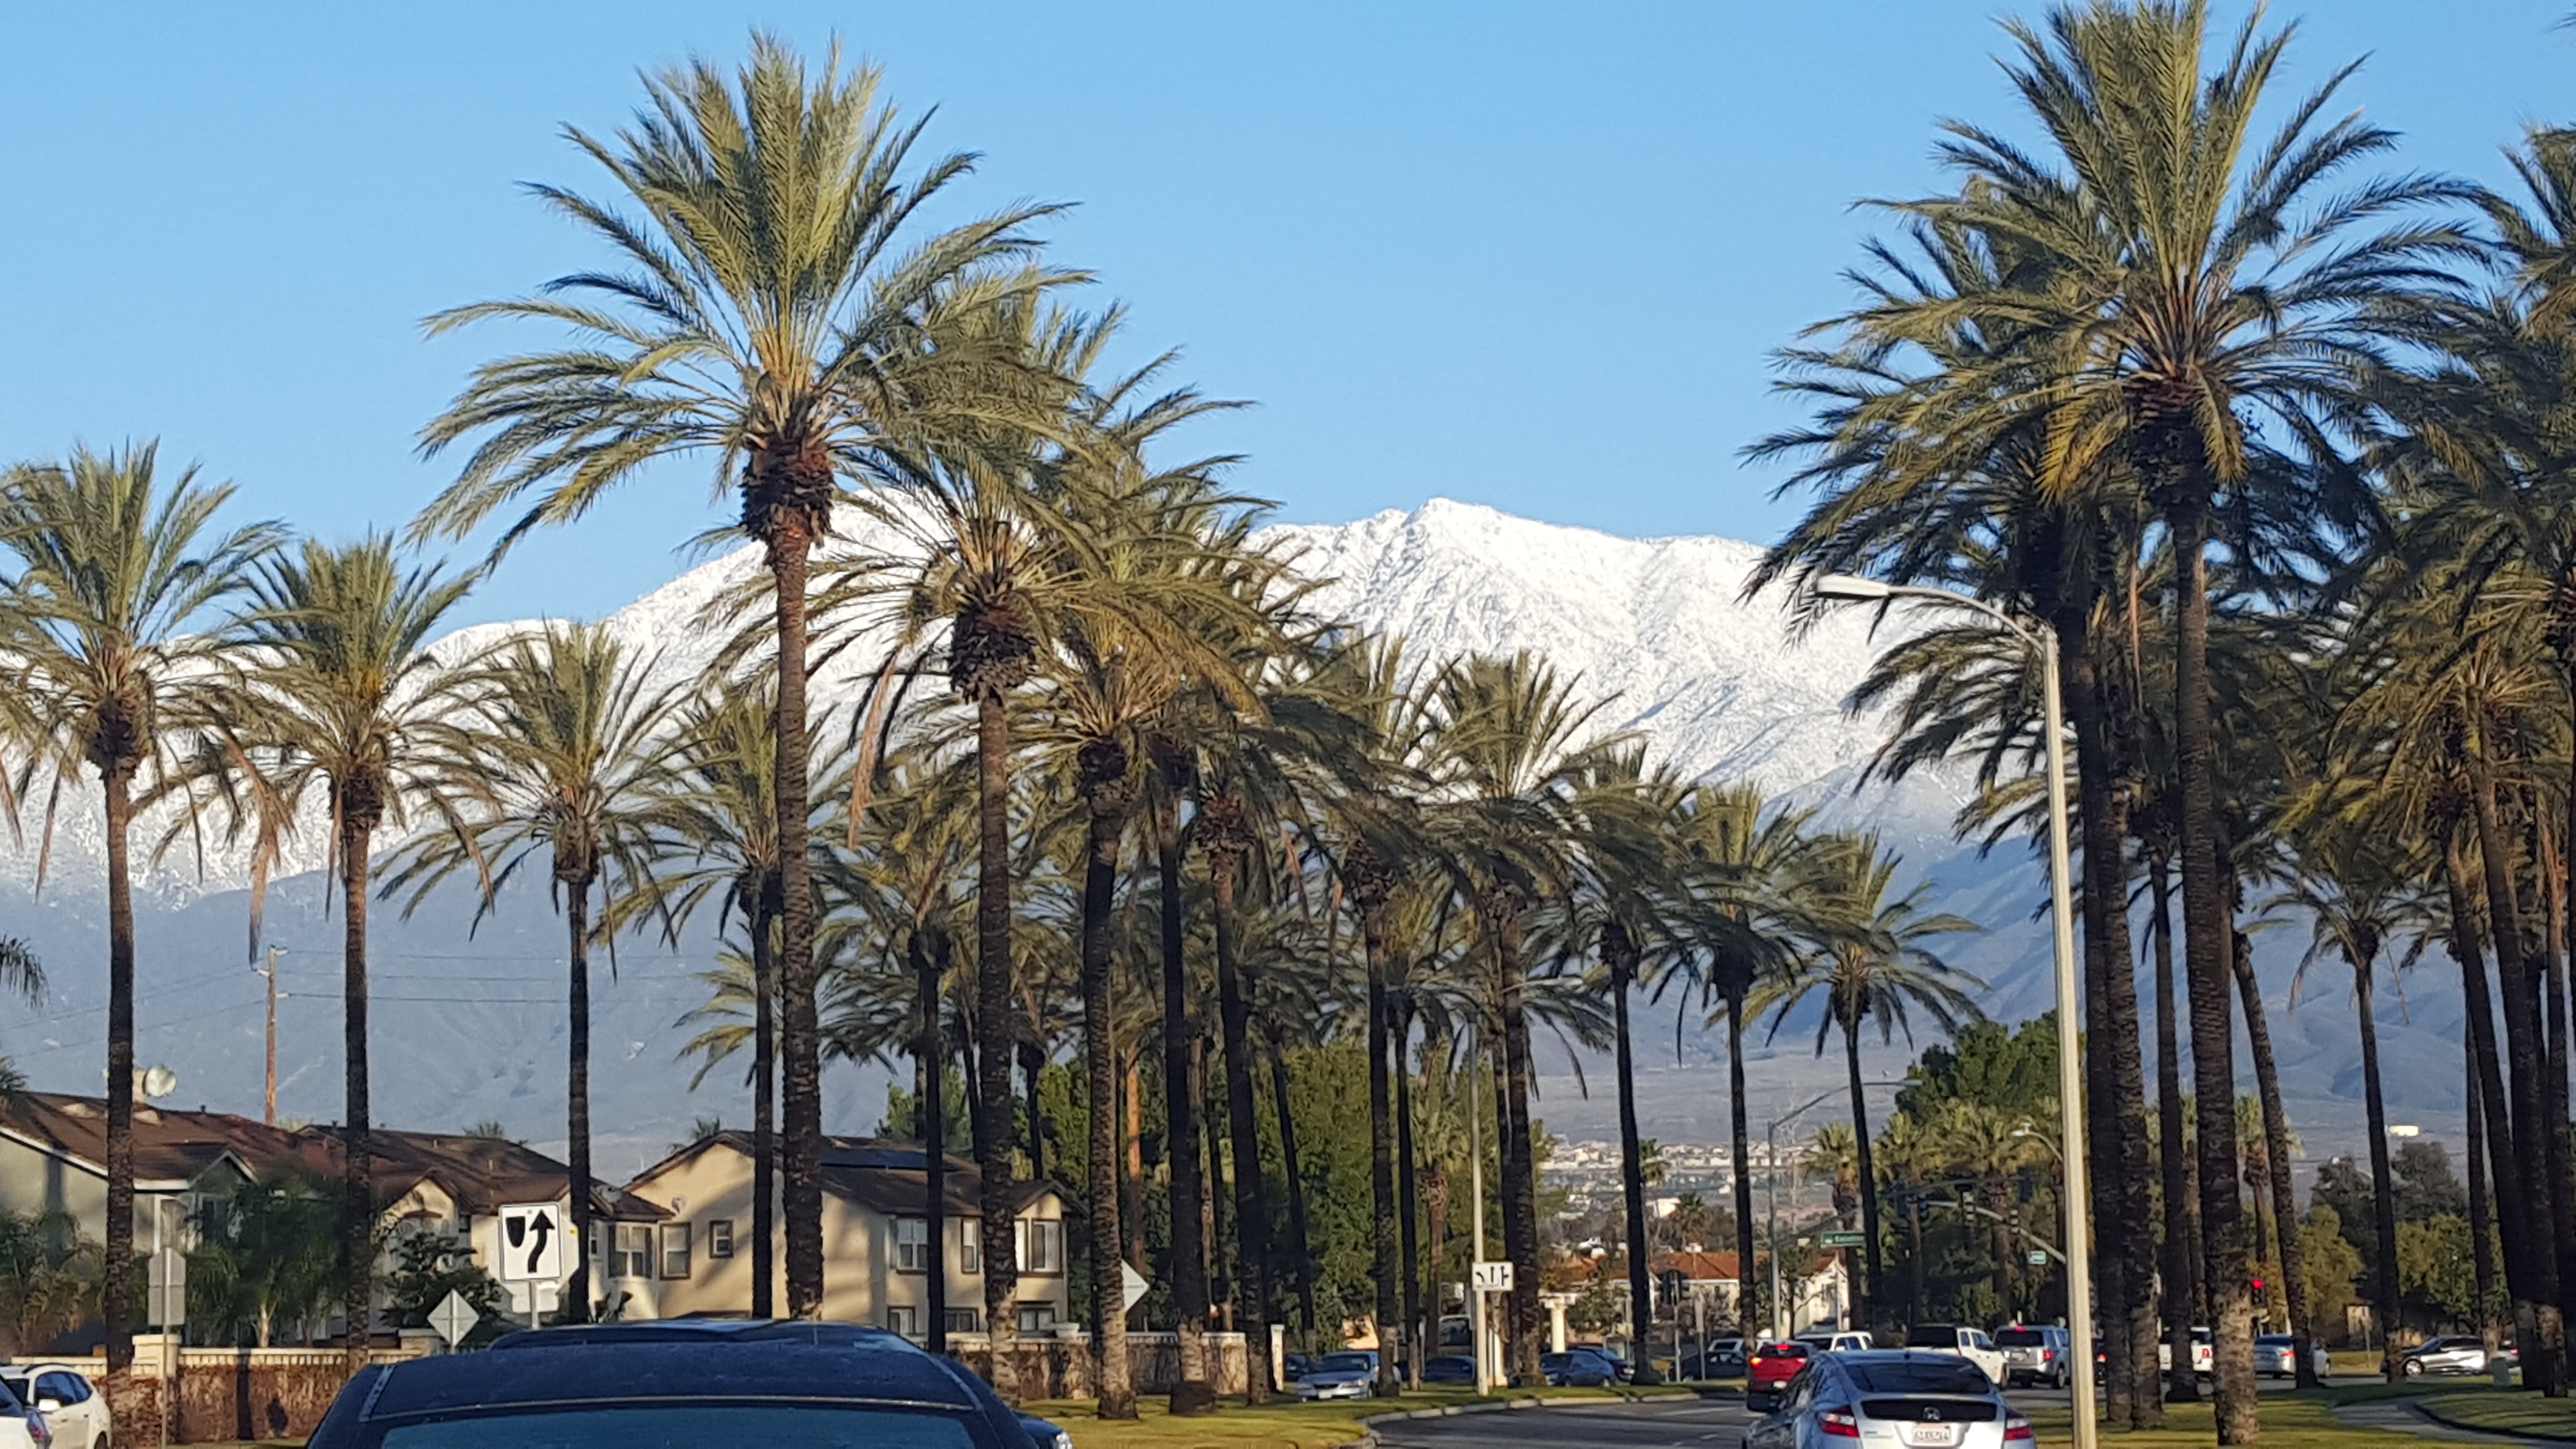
<box><xmin>1744</xmin><ymin>1349</ymin><xmax>2035</xmax><ymax>1449</ymax></box>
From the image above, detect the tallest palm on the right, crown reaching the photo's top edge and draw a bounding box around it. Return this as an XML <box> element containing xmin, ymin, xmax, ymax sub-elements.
<box><xmin>1901</xmin><ymin>0</ymin><xmax>2473</xmax><ymax>1444</ymax></box>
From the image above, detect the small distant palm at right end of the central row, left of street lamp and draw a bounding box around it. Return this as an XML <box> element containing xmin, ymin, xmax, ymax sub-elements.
<box><xmin>1752</xmin><ymin>833</ymin><xmax>1983</xmax><ymax>1320</ymax></box>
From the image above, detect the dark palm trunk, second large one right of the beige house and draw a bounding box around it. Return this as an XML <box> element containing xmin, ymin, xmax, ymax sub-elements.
<box><xmin>1154</xmin><ymin>784</ymin><xmax>1216</xmax><ymax>1416</ymax></box>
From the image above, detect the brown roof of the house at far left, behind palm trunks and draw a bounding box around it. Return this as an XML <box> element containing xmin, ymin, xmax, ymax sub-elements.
<box><xmin>0</xmin><ymin>1091</ymin><xmax>670</xmax><ymax>1222</ymax></box>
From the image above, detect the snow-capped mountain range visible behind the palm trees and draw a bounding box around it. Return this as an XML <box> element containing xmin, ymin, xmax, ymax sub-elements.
<box><xmin>0</xmin><ymin>500</ymin><xmax>2460</xmax><ymax>1171</ymax></box>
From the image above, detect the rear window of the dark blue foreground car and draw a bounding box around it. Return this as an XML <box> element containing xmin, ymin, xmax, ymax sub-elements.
<box><xmin>373</xmin><ymin>1402</ymin><xmax>976</xmax><ymax>1449</ymax></box>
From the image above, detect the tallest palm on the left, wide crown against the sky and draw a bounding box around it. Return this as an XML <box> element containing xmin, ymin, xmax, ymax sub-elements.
<box><xmin>412</xmin><ymin>33</ymin><xmax>1056</xmax><ymax>1318</ymax></box>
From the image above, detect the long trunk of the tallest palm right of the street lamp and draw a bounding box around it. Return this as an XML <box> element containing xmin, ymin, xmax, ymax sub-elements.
<box><xmin>2166</xmin><ymin>487</ymin><xmax>2262</xmax><ymax>1444</ymax></box>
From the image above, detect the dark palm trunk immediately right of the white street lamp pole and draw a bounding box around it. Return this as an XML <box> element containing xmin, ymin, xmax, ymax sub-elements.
<box><xmin>2056</xmin><ymin>598</ymin><xmax>2164</xmax><ymax>1428</ymax></box>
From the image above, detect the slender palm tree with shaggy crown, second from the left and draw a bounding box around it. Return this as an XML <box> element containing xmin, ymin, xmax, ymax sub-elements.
<box><xmin>224</xmin><ymin>534</ymin><xmax>474</xmax><ymax>1369</ymax></box>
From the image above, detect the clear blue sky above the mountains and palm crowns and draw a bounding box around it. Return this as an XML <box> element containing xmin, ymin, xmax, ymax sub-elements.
<box><xmin>0</xmin><ymin>0</ymin><xmax>2576</xmax><ymax>619</ymax></box>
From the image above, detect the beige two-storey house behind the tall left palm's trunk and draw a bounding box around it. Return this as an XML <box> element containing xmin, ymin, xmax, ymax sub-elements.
<box><xmin>628</xmin><ymin>1132</ymin><xmax>1074</xmax><ymax>1338</ymax></box>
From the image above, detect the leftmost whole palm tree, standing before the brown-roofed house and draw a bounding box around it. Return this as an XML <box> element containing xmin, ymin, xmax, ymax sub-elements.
<box><xmin>0</xmin><ymin>443</ymin><xmax>281</xmax><ymax>1410</ymax></box>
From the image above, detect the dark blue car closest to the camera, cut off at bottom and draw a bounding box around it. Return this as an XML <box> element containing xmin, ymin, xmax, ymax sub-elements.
<box><xmin>309</xmin><ymin>1318</ymin><xmax>1033</xmax><ymax>1449</ymax></box>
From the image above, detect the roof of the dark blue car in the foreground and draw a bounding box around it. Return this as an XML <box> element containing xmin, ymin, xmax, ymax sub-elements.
<box><xmin>348</xmin><ymin>1320</ymin><xmax>986</xmax><ymax>1423</ymax></box>
